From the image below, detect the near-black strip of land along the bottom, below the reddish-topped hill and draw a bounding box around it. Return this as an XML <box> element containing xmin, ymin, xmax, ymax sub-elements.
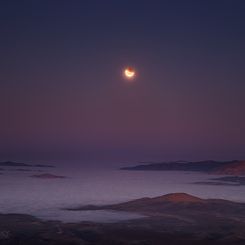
<box><xmin>0</xmin><ymin>214</ymin><xmax>245</xmax><ymax>245</ymax></box>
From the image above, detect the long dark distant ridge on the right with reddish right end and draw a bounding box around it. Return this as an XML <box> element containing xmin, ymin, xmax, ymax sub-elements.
<box><xmin>121</xmin><ymin>160</ymin><xmax>245</xmax><ymax>175</ymax></box>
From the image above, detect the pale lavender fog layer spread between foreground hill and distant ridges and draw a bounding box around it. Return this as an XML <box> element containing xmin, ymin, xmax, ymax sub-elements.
<box><xmin>0</xmin><ymin>167</ymin><xmax>245</xmax><ymax>222</ymax></box>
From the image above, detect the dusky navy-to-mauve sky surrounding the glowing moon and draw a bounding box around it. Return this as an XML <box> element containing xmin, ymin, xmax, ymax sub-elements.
<box><xmin>0</xmin><ymin>0</ymin><xmax>245</xmax><ymax>164</ymax></box>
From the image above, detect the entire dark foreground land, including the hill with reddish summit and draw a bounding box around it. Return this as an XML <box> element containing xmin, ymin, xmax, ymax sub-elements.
<box><xmin>0</xmin><ymin>193</ymin><xmax>245</xmax><ymax>245</ymax></box>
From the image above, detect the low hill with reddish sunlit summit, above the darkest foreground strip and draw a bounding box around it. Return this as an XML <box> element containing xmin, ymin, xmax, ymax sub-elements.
<box><xmin>68</xmin><ymin>193</ymin><xmax>245</xmax><ymax>217</ymax></box>
